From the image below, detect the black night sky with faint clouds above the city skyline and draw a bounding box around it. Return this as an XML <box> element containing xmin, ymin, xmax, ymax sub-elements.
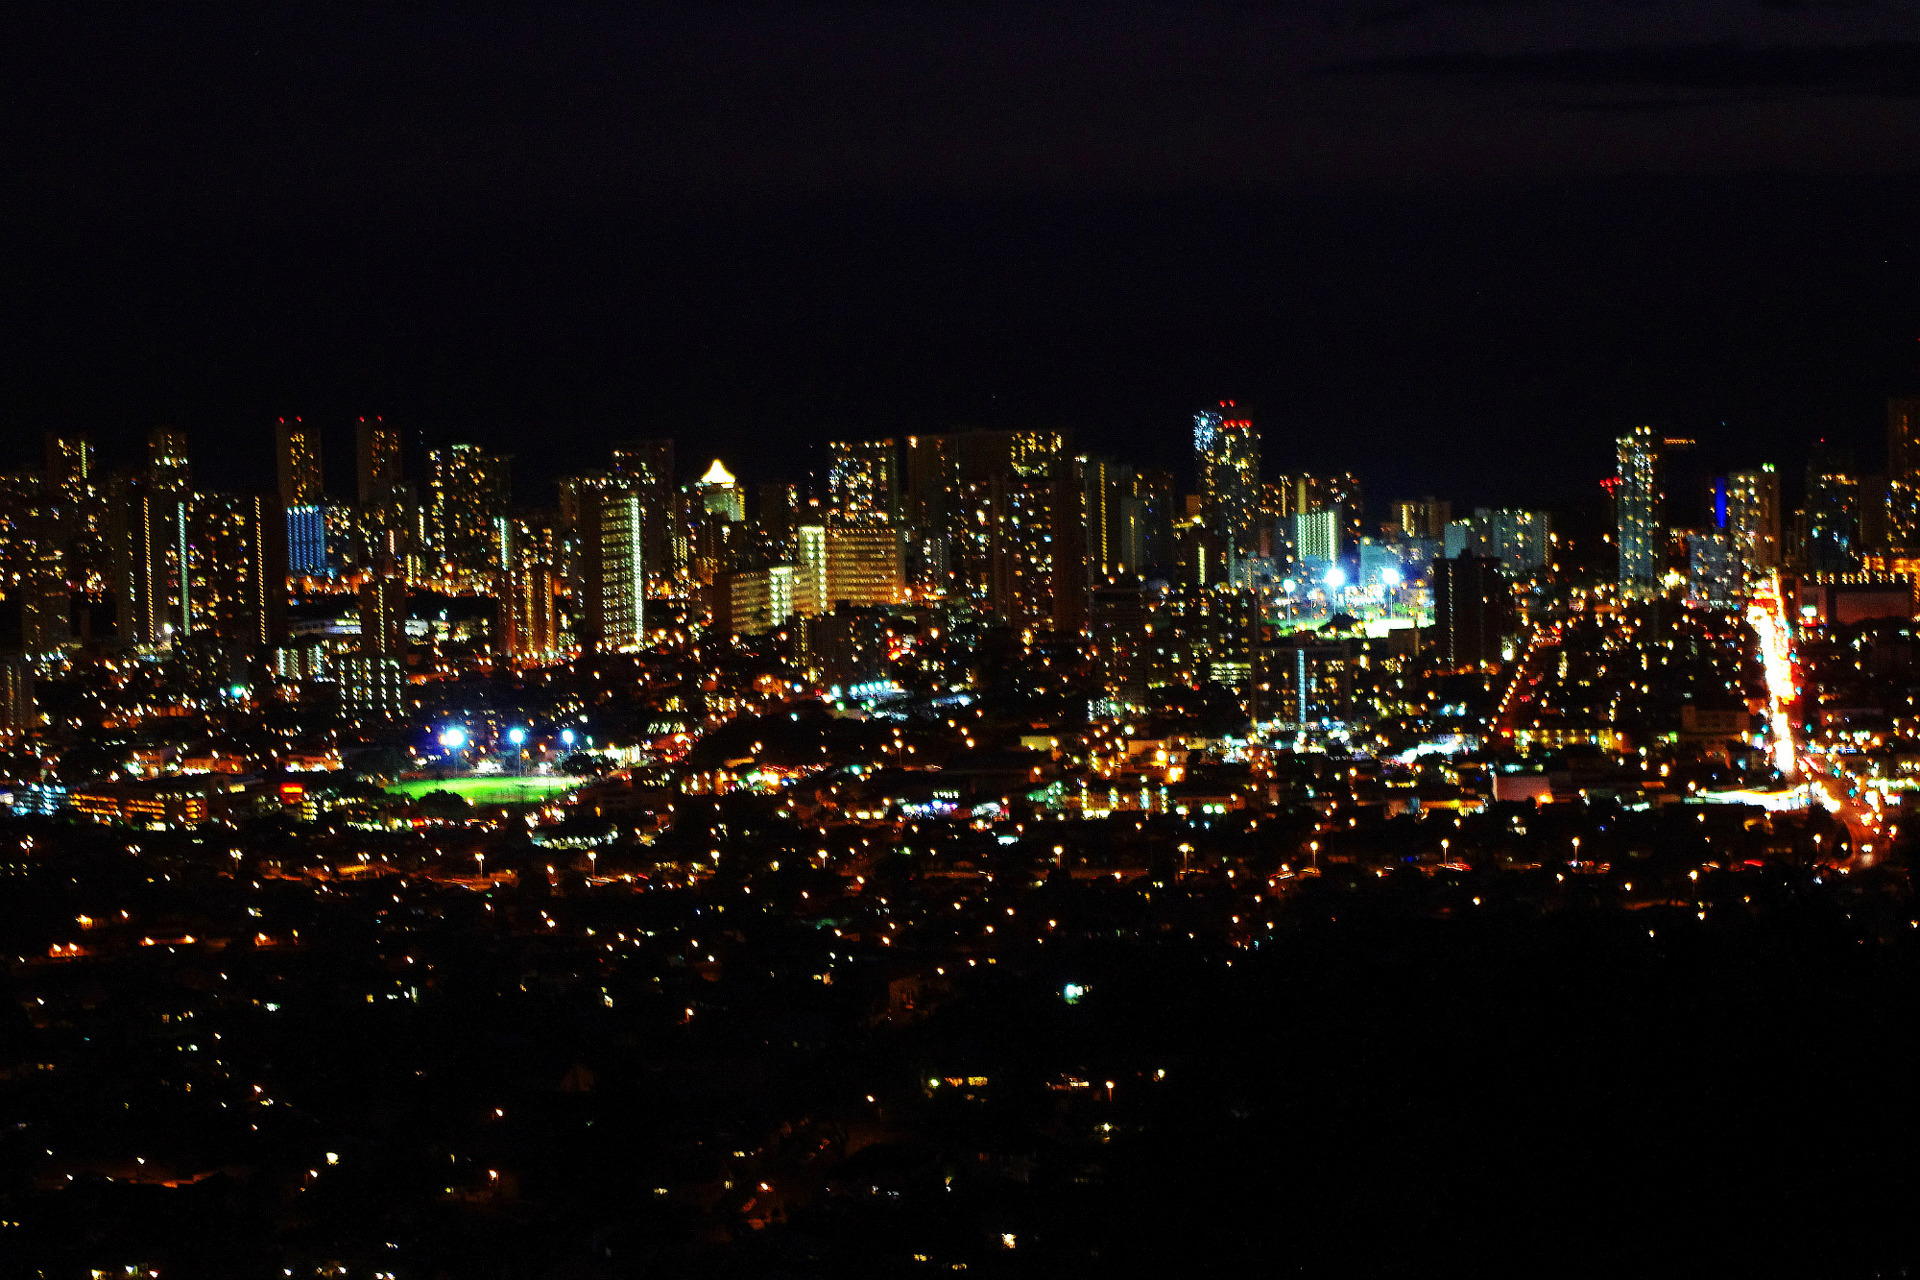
<box><xmin>0</xmin><ymin>0</ymin><xmax>1920</xmax><ymax>514</ymax></box>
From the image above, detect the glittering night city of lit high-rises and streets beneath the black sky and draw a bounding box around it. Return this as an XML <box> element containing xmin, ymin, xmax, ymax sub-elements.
<box><xmin>0</xmin><ymin>395</ymin><xmax>1920</xmax><ymax>1267</ymax></box>
